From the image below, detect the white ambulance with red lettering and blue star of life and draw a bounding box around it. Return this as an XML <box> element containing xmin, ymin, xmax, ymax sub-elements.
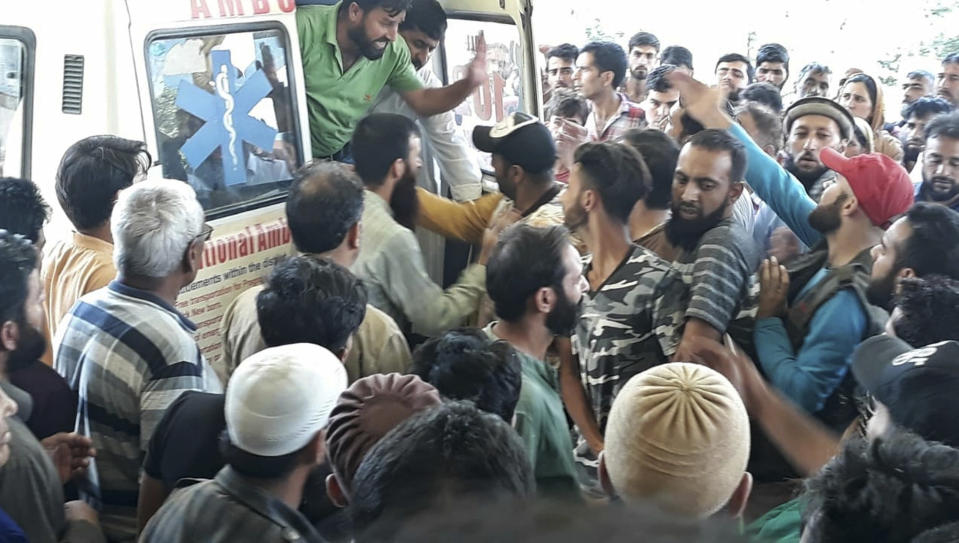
<box><xmin>0</xmin><ymin>0</ymin><xmax>541</xmax><ymax>369</ymax></box>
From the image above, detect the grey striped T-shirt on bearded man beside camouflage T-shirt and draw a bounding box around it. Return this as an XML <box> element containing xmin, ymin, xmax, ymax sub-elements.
<box><xmin>673</xmin><ymin>217</ymin><xmax>760</xmax><ymax>333</ymax></box>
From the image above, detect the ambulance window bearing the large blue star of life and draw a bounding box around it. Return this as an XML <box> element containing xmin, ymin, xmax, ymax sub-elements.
<box><xmin>146</xmin><ymin>27</ymin><xmax>303</xmax><ymax>217</ymax></box>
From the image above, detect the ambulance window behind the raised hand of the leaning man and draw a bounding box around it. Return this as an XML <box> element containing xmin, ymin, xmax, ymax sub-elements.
<box><xmin>445</xmin><ymin>17</ymin><xmax>525</xmax><ymax>172</ymax></box>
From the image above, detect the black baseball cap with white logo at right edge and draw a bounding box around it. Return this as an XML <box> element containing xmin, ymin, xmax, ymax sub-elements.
<box><xmin>852</xmin><ymin>335</ymin><xmax>959</xmax><ymax>447</ymax></box>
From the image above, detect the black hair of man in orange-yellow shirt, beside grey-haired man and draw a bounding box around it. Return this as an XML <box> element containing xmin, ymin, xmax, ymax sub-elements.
<box><xmin>57</xmin><ymin>136</ymin><xmax>153</xmax><ymax>232</ymax></box>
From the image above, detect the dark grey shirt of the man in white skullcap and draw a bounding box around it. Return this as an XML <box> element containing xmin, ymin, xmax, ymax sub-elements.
<box><xmin>140</xmin><ymin>466</ymin><xmax>323</xmax><ymax>543</ymax></box>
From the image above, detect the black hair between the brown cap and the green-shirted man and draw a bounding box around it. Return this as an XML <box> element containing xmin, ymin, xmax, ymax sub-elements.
<box><xmin>410</xmin><ymin>328</ymin><xmax>521</xmax><ymax>422</ymax></box>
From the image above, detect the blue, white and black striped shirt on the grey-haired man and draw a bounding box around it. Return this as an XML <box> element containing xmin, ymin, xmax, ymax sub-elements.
<box><xmin>55</xmin><ymin>281</ymin><xmax>222</xmax><ymax>540</ymax></box>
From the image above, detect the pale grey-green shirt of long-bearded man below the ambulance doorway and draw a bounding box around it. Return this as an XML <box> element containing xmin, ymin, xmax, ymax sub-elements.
<box><xmin>352</xmin><ymin>191</ymin><xmax>486</xmax><ymax>336</ymax></box>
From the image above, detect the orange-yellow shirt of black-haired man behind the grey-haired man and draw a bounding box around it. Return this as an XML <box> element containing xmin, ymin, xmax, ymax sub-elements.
<box><xmin>42</xmin><ymin>232</ymin><xmax>117</xmax><ymax>344</ymax></box>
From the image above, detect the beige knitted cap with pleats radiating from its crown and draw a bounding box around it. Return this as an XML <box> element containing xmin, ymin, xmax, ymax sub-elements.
<box><xmin>604</xmin><ymin>362</ymin><xmax>749</xmax><ymax>518</ymax></box>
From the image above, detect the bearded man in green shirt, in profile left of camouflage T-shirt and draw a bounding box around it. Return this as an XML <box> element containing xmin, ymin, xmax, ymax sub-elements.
<box><xmin>486</xmin><ymin>224</ymin><xmax>588</xmax><ymax>498</ymax></box>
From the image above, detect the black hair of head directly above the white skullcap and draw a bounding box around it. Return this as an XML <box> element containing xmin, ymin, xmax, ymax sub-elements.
<box><xmin>256</xmin><ymin>256</ymin><xmax>366</xmax><ymax>353</ymax></box>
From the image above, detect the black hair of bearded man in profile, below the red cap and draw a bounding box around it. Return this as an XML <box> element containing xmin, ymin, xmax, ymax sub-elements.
<box><xmin>896</xmin><ymin>202</ymin><xmax>959</xmax><ymax>280</ymax></box>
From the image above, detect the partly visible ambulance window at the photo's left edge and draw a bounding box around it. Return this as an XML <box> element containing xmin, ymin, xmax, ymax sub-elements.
<box><xmin>0</xmin><ymin>31</ymin><xmax>33</xmax><ymax>177</ymax></box>
